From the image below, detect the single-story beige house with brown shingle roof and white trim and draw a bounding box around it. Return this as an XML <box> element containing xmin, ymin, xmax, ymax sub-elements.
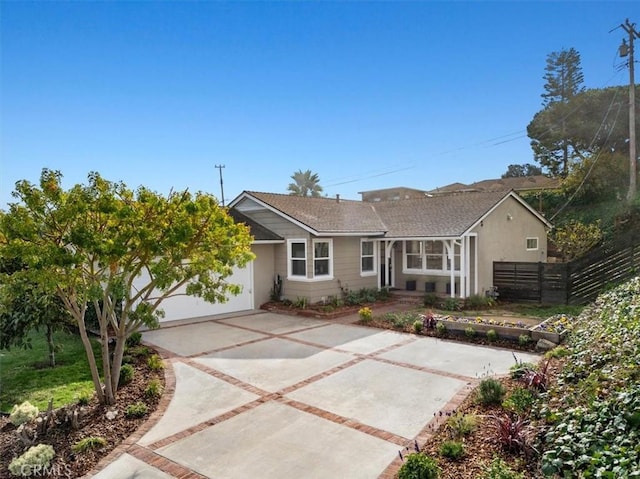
<box><xmin>154</xmin><ymin>191</ymin><xmax>551</xmax><ymax>321</ymax></box>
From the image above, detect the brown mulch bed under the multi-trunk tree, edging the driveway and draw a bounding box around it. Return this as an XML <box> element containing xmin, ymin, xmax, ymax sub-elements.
<box><xmin>0</xmin><ymin>350</ymin><xmax>164</xmax><ymax>479</ymax></box>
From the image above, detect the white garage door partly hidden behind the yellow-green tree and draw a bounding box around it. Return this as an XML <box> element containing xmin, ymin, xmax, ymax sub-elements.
<box><xmin>134</xmin><ymin>263</ymin><xmax>253</xmax><ymax>323</ymax></box>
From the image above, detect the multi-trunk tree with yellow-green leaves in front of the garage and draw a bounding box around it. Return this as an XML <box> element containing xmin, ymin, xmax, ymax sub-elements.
<box><xmin>0</xmin><ymin>169</ymin><xmax>253</xmax><ymax>404</ymax></box>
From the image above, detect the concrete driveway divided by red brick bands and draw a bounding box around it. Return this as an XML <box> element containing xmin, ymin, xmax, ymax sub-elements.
<box><xmin>93</xmin><ymin>312</ymin><xmax>539</xmax><ymax>479</ymax></box>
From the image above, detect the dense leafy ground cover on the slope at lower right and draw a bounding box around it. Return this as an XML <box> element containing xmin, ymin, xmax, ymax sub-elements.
<box><xmin>540</xmin><ymin>277</ymin><xmax>640</xmax><ymax>477</ymax></box>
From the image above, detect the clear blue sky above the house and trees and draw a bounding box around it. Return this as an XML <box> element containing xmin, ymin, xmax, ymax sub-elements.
<box><xmin>0</xmin><ymin>1</ymin><xmax>640</xmax><ymax>208</ymax></box>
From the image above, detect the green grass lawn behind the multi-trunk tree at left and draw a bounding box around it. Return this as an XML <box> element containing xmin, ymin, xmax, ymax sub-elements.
<box><xmin>0</xmin><ymin>331</ymin><xmax>101</xmax><ymax>412</ymax></box>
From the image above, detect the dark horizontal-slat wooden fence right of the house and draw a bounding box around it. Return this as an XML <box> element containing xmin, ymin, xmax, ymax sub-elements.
<box><xmin>493</xmin><ymin>232</ymin><xmax>640</xmax><ymax>304</ymax></box>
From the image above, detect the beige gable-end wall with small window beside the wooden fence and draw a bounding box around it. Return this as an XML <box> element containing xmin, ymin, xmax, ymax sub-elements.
<box><xmin>473</xmin><ymin>198</ymin><xmax>547</xmax><ymax>294</ymax></box>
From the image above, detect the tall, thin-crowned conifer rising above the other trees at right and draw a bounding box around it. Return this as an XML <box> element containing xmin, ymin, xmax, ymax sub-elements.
<box><xmin>527</xmin><ymin>48</ymin><xmax>584</xmax><ymax>176</ymax></box>
